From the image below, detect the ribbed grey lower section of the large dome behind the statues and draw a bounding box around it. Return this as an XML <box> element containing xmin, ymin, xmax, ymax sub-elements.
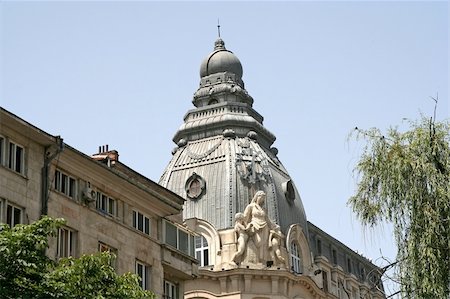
<box><xmin>164</xmin><ymin>136</ymin><xmax>307</xmax><ymax>233</ymax></box>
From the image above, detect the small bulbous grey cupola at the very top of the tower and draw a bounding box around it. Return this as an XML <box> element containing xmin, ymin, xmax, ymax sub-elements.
<box><xmin>200</xmin><ymin>38</ymin><xmax>242</xmax><ymax>78</ymax></box>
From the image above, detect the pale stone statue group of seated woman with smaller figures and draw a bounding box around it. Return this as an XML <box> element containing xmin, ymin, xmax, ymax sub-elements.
<box><xmin>231</xmin><ymin>191</ymin><xmax>286</xmax><ymax>267</ymax></box>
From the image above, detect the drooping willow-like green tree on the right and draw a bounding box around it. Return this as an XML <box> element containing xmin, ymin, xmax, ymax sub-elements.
<box><xmin>349</xmin><ymin>118</ymin><xmax>450</xmax><ymax>299</ymax></box>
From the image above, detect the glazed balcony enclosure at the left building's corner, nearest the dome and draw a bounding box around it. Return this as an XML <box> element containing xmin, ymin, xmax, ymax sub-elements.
<box><xmin>164</xmin><ymin>221</ymin><xmax>195</xmax><ymax>256</ymax></box>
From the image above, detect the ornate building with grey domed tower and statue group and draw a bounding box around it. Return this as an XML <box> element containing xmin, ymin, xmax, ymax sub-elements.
<box><xmin>160</xmin><ymin>38</ymin><xmax>384</xmax><ymax>299</ymax></box>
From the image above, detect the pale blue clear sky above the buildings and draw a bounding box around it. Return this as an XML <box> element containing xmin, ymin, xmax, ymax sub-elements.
<box><xmin>0</xmin><ymin>1</ymin><xmax>450</xmax><ymax>296</ymax></box>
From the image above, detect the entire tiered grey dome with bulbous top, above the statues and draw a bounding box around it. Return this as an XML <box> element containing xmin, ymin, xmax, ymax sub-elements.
<box><xmin>159</xmin><ymin>38</ymin><xmax>308</xmax><ymax>235</ymax></box>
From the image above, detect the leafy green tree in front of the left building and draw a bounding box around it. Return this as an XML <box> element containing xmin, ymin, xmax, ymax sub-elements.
<box><xmin>0</xmin><ymin>217</ymin><xmax>154</xmax><ymax>299</ymax></box>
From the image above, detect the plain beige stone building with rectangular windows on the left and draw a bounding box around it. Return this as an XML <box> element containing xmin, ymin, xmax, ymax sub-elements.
<box><xmin>0</xmin><ymin>108</ymin><xmax>198</xmax><ymax>298</ymax></box>
